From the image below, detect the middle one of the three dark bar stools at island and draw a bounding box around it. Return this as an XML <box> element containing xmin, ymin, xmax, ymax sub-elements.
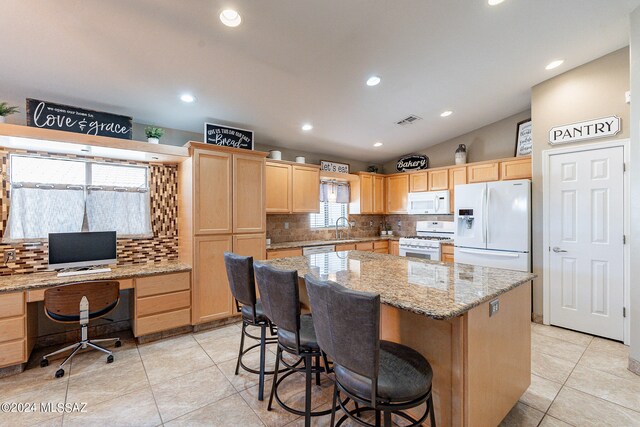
<box><xmin>255</xmin><ymin>262</ymin><xmax>331</xmax><ymax>427</ymax></box>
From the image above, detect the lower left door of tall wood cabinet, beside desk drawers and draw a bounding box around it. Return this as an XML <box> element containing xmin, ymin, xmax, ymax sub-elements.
<box><xmin>192</xmin><ymin>235</ymin><xmax>238</xmax><ymax>323</ymax></box>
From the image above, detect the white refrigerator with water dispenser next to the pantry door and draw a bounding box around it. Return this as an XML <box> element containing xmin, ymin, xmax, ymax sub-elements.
<box><xmin>454</xmin><ymin>179</ymin><xmax>531</xmax><ymax>272</ymax></box>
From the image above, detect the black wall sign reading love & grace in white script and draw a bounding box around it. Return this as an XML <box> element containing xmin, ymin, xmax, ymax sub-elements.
<box><xmin>27</xmin><ymin>98</ymin><xmax>132</xmax><ymax>139</ymax></box>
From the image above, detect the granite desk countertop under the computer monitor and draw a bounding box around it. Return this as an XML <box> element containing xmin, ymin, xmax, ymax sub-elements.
<box><xmin>0</xmin><ymin>261</ymin><xmax>191</xmax><ymax>293</ymax></box>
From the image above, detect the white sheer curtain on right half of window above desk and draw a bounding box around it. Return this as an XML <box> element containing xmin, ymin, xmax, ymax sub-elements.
<box><xmin>87</xmin><ymin>190</ymin><xmax>153</xmax><ymax>237</ymax></box>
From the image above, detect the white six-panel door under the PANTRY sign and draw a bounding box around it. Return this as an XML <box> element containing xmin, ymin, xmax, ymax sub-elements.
<box><xmin>546</xmin><ymin>147</ymin><xmax>624</xmax><ymax>340</ymax></box>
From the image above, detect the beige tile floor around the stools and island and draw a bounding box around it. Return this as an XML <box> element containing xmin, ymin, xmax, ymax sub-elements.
<box><xmin>0</xmin><ymin>324</ymin><xmax>640</xmax><ymax>427</ymax></box>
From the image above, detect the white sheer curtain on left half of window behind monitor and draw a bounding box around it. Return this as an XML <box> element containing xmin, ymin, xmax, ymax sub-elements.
<box><xmin>3</xmin><ymin>187</ymin><xmax>84</xmax><ymax>242</ymax></box>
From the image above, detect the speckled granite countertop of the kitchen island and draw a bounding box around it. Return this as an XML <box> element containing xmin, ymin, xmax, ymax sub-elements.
<box><xmin>260</xmin><ymin>251</ymin><xmax>536</xmax><ymax>319</ymax></box>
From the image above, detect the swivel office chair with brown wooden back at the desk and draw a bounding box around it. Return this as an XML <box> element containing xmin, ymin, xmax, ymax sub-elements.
<box><xmin>40</xmin><ymin>280</ymin><xmax>122</xmax><ymax>378</ymax></box>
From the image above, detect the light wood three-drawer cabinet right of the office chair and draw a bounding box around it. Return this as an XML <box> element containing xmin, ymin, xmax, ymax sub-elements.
<box><xmin>133</xmin><ymin>272</ymin><xmax>191</xmax><ymax>337</ymax></box>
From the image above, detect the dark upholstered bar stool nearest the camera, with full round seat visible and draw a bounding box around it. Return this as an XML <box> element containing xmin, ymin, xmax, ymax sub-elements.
<box><xmin>305</xmin><ymin>274</ymin><xmax>436</xmax><ymax>427</ymax></box>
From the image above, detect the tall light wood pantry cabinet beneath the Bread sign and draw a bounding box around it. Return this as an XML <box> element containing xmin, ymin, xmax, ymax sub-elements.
<box><xmin>178</xmin><ymin>142</ymin><xmax>267</xmax><ymax>324</ymax></box>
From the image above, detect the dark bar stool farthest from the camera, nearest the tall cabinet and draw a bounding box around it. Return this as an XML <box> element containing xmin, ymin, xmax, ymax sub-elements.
<box><xmin>224</xmin><ymin>252</ymin><xmax>277</xmax><ymax>400</ymax></box>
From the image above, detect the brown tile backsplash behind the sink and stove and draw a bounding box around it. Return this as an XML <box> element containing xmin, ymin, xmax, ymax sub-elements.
<box><xmin>267</xmin><ymin>214</ymin><xmax>453</xmax><ymax>243</ymax></box>
